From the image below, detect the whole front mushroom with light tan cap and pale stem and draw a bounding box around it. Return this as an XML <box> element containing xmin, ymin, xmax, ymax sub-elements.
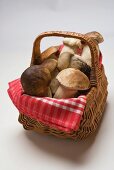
<box><xmin>54</xmin><ymin>68</ymin><xmax>90</xmax><ymax>98</ymax></box>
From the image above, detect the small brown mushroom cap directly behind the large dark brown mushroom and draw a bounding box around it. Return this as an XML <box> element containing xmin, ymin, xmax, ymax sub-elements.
<box><xmin>41</xmin><ymin>59</ymin><xmax>57</xmax><ymax>72</ymax></box>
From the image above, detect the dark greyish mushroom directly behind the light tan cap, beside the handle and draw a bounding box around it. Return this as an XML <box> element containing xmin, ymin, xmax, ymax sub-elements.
<box><xmin>69</xmin><ymin>55</ymin><xmax>91</xmax><ymax>78</ymax></box>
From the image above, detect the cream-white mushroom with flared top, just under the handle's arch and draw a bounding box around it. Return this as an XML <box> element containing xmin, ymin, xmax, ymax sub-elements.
<box><xmin>60</xmin><ymin>38</ymin><xmax>82</xmax><ymax>54</ymax></box>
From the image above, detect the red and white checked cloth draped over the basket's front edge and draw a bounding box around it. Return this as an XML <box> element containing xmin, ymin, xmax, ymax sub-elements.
<box><xmin>8</xmin><ymin>79</ymin><xmax>86</xmax><ymax>132</ymax></box>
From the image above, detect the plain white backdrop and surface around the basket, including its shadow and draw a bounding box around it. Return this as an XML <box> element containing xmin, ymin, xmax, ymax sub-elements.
<box><xmin>0</xmin><ymin>0</ymin><xmax>114</xmax><ymax>170</ymax></box>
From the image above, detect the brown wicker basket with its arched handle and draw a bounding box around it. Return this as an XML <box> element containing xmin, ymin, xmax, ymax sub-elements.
<box><xmin>18</xmin><ymin>31</ymin><xmax>108</xmax><ymax>139</ymax></box>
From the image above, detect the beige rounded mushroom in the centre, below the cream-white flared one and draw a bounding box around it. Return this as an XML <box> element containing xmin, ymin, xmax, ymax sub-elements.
<box><xmin>57</xmin><ymin>52</ymin><xmax>72</xmax><ymax>71</ymax></box>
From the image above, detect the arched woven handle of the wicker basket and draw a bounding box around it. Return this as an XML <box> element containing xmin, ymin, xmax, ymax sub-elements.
<box><xmin>31</xmin><ymin>31</ymin><xmax>100</xmax><ymax>86</ymax></box>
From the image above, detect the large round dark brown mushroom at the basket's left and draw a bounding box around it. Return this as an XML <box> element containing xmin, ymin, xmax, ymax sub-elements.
<box><xmin>21</xmin><ymin>65</ymin><xmax>51</xmax><ymax>97</ymax></box>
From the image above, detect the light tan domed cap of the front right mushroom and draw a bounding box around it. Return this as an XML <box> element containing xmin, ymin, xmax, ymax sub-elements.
<box><xmin>56</xmin><ymin>68</ymin><xmax>90</xmax><ymax>90</ymax></box>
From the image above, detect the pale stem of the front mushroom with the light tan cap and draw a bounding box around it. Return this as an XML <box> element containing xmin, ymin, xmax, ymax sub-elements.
<box><xmin>54</xmin><ymin>85</ymin><xmax>77</xmax><ymax>99</ymax></box>
